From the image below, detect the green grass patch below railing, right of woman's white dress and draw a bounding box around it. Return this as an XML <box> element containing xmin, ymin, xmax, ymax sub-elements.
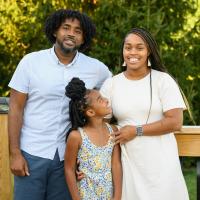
<box><xmin>183</xmin><ymin>168</ymin><xmax>197</xmax><ymax>200</ymax></box>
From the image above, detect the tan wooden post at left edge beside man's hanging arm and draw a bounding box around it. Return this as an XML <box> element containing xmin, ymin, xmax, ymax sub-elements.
<box><xmin>0</xmin><ymin>114</ymin><xmax>13</xmax><ymax>200</ymax></box>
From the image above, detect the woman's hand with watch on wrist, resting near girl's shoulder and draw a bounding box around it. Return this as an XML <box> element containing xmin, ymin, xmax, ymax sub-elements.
<box><xmin>114</xmin><ymin>125</ymin><xmax>136</xmax><ymax>144</ymax></box>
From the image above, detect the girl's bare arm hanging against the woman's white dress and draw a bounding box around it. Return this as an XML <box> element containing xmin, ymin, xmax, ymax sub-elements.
<box><xmin>112</xmin><ymin>144</ymin><xmax>122</xmax><ymax>200</ymax></box>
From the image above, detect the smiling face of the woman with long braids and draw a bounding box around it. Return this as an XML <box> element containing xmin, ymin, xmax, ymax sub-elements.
<box><xmin>123</xmin><ymin>33</ymin><xmax>149</xmax><ymax>70</ymax></box>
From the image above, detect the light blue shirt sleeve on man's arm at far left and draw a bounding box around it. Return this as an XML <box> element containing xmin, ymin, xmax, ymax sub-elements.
<box><xmin>8</xmin><ymin>56</ymin><xmax>30</xmax><ymax>94</ymax></box>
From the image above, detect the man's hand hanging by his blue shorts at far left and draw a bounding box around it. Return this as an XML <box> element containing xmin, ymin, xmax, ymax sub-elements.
<box><xmin>10</xmin><ymin>152</ymin><xmax>30</xmax><ymax>176</ymax></box>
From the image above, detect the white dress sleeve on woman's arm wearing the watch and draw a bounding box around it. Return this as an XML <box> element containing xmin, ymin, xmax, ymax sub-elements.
<box><xmin>159</xmin><ymin>73</ymin><xmax>186</xmax><ymax>112</ymax></box>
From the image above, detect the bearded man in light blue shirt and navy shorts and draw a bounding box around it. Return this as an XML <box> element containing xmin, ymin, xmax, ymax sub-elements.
<box><xmin>8</xmin><ymin>9</ymin><xmax>111</xmax><ymax>200</ymax></box>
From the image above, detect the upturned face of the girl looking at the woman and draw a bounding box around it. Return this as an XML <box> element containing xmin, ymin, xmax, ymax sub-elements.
<box><xmin>87</xmin><ymin>90</ymin><xmax>112</xmax><ymax>117</ymax></box>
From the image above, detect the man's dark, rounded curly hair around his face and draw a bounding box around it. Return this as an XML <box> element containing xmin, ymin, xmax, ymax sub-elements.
<box><xmin>45</xmin><ymin>9</ymin><xmax>96</xmax><ymax>51</ymax></box>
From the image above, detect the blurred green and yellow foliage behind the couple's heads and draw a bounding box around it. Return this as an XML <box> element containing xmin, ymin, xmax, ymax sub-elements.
<box><xmin>0</xmin><ymin>0</ymin><xmax>200</xmax><ymax>125</ymax></box>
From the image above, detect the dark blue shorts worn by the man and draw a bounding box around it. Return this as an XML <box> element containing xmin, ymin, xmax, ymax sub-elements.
<box><xmin>14</xmin><ymin>151</ymin><xmax>71</xmax><ymax>200</ymax></box>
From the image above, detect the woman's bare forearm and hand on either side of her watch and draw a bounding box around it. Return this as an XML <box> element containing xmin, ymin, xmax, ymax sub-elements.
<box><xmin>115</xmin><ymin>108</ymin><xmax>183</xmax><ymax>144</ymax></box>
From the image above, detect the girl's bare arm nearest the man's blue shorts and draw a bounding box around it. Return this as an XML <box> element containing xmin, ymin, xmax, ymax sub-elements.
<box><xmin>64</xmin><ymin>131</ymin><xmax>81</xmax><ymax>200</ymax></box>
